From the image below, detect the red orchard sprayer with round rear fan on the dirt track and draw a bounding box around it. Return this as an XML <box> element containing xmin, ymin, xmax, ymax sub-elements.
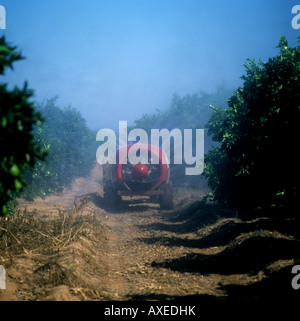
<box><xmin>103</xmin><ymin>144</ymin><xmax>173</xmax><ymax>210</ymax></box>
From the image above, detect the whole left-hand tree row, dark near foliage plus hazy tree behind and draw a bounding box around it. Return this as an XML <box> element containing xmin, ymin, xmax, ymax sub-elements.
<box><xmin>0</xmin><ymin>37</ymin><xmax>95</xmax><ymax>215</ymax></box>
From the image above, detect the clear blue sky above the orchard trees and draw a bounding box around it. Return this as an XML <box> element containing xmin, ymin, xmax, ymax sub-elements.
<box><xmin>0</xmin><ymin>0</ymin><xmax>300</xmax><ymax>129</ymax></box>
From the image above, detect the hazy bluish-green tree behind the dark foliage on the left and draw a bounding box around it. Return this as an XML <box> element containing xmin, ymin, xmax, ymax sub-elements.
<box><xmin>21</xmin><ymin>98</ymin><xmax>95</xmax><ymax>200</ymax></box>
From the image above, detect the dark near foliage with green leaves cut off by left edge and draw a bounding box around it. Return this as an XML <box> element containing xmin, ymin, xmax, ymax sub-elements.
<box><xmin>0</xmin><ymin>37</ymin><xmax>45</xmax><ymax>215</ymax></box>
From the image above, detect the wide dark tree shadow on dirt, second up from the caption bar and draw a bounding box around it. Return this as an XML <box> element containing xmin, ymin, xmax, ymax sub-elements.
<box><xmin>151</xmin><ymin>235</ymin><xmax>300</xmax><ymax>275</ymax></box>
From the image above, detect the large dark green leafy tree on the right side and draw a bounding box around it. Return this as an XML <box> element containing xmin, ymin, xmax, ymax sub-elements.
<box><xmin>204</xmin><ymin>37</ymin><xmax>300</xmax><ymax>209</ymax></box>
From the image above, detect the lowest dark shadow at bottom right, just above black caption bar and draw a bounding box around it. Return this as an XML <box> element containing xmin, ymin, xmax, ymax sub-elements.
<box><xmin>129</xmin><ymin>266</ymin><xmax>300</xmax><ymax>304</ymax></box>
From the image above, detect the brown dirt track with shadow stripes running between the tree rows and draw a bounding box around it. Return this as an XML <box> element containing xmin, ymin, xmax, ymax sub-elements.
<box><xmin>0</xmin><ymin>164</ymin><xmax>298</xmax><ymax>300</ymax></box>
